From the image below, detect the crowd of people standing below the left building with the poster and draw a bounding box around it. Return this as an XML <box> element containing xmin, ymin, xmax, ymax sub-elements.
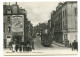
<box><xmin>9</xmin><ymin>41</ymin><xmax>34</xmax><ymax>52</ymax></box>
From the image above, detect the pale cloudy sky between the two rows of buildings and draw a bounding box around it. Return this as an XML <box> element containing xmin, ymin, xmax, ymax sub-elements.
<box><xmin>4</xmin><ymin>2</ymin><xmax>59</xmax><ymax>26</ymax></box>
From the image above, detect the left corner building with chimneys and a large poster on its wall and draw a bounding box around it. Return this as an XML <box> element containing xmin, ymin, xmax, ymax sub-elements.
<box><xmin>3</xmin><ymin>3</ymin><xmax>31</xmax><ymax>47</ymax></box>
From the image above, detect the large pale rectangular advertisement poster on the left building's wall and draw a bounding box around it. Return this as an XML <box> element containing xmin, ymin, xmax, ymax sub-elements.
<box><xmin>12</xmin><ymin>15</ymin><xmax>24</xmax><ymax>32</ymax></box>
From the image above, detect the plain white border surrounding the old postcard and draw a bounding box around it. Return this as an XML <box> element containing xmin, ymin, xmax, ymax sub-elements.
<box><xmin>0</xmin><ymin>0</ymin><xmax>80</xmax><ymax>57</ymax></box>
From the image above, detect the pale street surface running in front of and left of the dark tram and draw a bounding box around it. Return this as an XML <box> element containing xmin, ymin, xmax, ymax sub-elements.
<box><xmin>34</xmin><ymin>36</ymin><xmax>71</xmax><ymax>50</ymax></box>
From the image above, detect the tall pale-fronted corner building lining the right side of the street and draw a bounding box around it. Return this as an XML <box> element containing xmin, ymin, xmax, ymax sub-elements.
<box><xmin>51</xmin><ymin>1</ymin><xmax>77</xmax><ymax>43</ymax></box>
